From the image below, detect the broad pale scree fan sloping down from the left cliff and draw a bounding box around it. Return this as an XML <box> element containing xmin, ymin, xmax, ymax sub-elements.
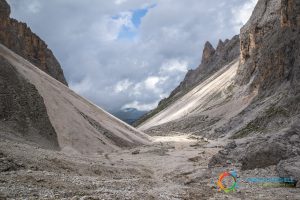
<box><xmin>0</xmin><ymin>44</ymin><xmax>152</xmax><ymax>154</ymax></box>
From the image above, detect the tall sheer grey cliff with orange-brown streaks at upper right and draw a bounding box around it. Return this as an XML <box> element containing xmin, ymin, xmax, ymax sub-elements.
<box><xmin>237</xmin><ymin>0</ymin><xmax>300</xmax><ymax>94</ymax></box>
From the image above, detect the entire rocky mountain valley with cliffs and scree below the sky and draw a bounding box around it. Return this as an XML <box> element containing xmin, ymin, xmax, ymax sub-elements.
<box><xmin>0</xmin><ymin>0</ymin><xmax>300</xmax><ymax>200</ymax></box>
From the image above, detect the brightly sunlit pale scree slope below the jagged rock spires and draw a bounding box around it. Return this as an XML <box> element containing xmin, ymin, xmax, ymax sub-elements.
<box><xmin>139</xmin><ymin>59</ymin><xmax>239</xmax><ymax>130</ymax></box>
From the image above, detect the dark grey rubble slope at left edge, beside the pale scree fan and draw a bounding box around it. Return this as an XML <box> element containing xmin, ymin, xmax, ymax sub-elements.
<box><xmin>0</xmin><ymin>56</ymin><xmax>59</xmax><ymax>149</ymax></box>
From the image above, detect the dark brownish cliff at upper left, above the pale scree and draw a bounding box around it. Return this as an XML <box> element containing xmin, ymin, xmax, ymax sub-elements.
<box><xmin>0</xmin><ymin>0</ymin><xmax>67</xmax><ymax>85</ymax></box>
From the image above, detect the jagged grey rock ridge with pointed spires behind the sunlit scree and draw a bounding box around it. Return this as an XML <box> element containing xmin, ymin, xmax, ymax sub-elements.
<box><xmin>134</xmin><ymin>35</ymin><xmax>240</xmax><ymax>126</ymax></box>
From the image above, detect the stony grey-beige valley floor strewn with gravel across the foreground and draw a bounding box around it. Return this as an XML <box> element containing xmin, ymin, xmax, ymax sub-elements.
<box><xmin>0</xmin><ymin>135</ymin><xmax>300</xmax><ymax>200</ymax></box>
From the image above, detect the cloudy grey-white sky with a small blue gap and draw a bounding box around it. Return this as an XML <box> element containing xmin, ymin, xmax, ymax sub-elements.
<box><xmin>8</xmin><ymin>0</ymin><xmax>257</xmax><ymax>112</ymax></box>
